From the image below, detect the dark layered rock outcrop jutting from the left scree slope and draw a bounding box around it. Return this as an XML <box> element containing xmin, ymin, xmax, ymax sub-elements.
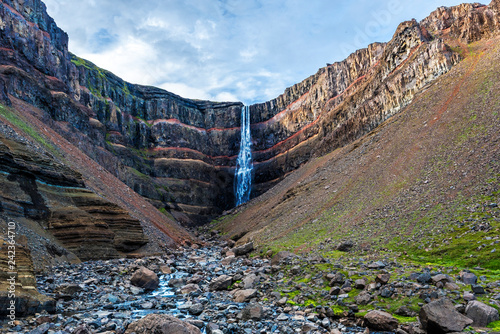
<box><xmin>0</xmin><ymin>136</ymin><xmax>147</xmax><ymax>260</ymax></box>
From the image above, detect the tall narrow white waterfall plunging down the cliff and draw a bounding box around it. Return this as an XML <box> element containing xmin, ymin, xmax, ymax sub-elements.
<box><xmin>234</xmin><ymin>106</ymin><xmax>253</xmax><ymax>206</ymax></box>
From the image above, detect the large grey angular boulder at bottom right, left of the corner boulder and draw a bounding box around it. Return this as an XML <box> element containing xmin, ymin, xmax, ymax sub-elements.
<box><xmin>419</xmin><ymin>298</ymin><xmax>472</xmax><ymax>334</ymax></box>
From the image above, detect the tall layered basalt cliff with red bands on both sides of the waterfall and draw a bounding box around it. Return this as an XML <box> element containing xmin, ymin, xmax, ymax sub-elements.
<box><xmin>0</xmin><ymin>0</ymin><xmax>499</xmax><ymax>223</ymax></box>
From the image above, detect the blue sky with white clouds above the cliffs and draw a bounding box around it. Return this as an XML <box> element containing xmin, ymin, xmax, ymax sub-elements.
<box><xmin>44</xmin><ymin>0</ymin><xmax>462</xmax><ymax>104</ymax></box>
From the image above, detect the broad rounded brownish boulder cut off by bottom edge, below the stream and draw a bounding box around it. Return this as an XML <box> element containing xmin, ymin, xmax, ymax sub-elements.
<box><xmin>125</xmin><ymin>314</ymin><xmax>201</xmax><ymax>334</ymax></box>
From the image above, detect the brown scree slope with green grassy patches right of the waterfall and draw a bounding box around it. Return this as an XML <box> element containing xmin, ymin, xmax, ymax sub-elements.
<box><xmin>214</xmin><ymin>38</ymin><xmax>500</xmax><ymax>269</ymax></box>
